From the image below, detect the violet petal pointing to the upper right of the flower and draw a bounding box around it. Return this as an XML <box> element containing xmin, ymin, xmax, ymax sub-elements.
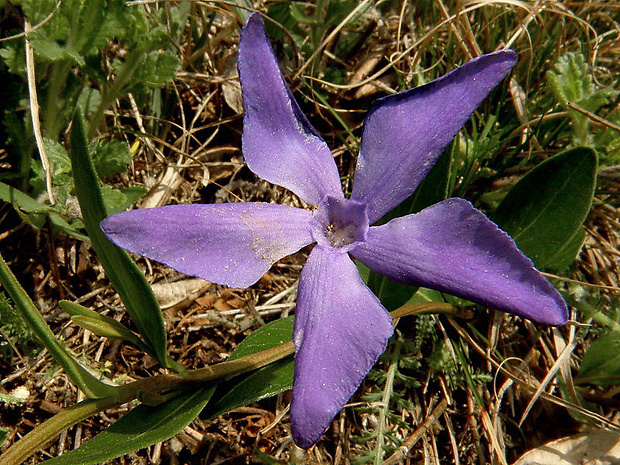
<box><xmin>351</xmin><ymin>50</ymin><xmax>517</xmax><ymax>224</ymax></box>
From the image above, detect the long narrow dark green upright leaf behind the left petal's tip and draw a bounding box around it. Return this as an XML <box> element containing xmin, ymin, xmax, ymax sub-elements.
<box><xmin>71</xmin><ymin>109</ymin><xmax>181</xmax><ymax>369</ymax></box>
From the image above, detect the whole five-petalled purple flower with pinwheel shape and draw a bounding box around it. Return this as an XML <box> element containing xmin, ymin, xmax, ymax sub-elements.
<box><xmin>101</xmin><ymin>14</ymin><xmax>567</xmax><ymax>448</ymax></box>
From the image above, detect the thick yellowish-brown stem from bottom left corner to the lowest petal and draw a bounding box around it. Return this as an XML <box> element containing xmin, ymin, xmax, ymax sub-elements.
<box><xmin>0</xmin><ymin>342</ymin><xmax>294</xmax><ymax>465</ymax></box>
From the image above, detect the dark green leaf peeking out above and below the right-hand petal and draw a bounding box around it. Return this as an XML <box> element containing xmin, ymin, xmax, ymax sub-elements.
<box><xmin>362</xmin><ymin>147</ymin><xmax>452</xmax><ymax>311</ymax></box>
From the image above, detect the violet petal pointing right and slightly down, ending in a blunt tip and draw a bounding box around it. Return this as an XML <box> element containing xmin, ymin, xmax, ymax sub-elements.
<box><xmin>352</xmin><ymin>198</ymin><xmax>568</xmax><ymax>325</ymax></box>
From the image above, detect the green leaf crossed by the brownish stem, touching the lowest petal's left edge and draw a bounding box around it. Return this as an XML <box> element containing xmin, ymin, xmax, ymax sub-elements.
<box><xmin>201</xmin><ymin>317</ymin><xmax>294</xmax><ymax>418</ymax></box>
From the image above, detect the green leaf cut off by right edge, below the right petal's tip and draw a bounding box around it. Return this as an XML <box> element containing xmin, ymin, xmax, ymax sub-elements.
<box><xmin>575</xmin><ymin>331</ymin><xmax>620</xmax><ymax>386</ymax></box>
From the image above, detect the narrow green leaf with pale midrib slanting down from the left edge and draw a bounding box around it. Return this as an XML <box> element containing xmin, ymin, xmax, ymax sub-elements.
<box><xmin>0</xmin><ymin>255</ymin><xmax>117</xmax><ymax>398</ymax></box>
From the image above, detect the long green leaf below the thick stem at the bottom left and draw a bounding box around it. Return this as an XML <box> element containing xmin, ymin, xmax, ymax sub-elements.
<box><xmin>43</xmin><ymin>386</ymin><xmax>215</xmax><ymax>465</ymax></box>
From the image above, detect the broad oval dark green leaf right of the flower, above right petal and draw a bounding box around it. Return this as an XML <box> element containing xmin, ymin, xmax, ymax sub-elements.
<box><xmin>491</xmin><ymin>147</ymin><xmax>597</xmax><ymax>268</ymax></box>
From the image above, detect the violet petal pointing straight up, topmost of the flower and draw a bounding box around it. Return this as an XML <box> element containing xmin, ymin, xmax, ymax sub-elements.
<box><xmin>239</xmin><ymin>14</ymin><xmax>343</xmax><ymax>205</ymax></box>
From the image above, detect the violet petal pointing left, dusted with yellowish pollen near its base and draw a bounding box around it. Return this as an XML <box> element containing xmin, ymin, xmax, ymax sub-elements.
<box><xmin>101</xmin><ymin>203</ymin><xmax>313</xmax><ymax>287</ymax></box>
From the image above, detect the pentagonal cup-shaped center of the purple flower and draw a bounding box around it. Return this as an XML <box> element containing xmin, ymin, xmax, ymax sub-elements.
<box><xmin>312</xmin><ymin>196</ymin><xmax>368</xmax><ymax>252</ymax></box>
